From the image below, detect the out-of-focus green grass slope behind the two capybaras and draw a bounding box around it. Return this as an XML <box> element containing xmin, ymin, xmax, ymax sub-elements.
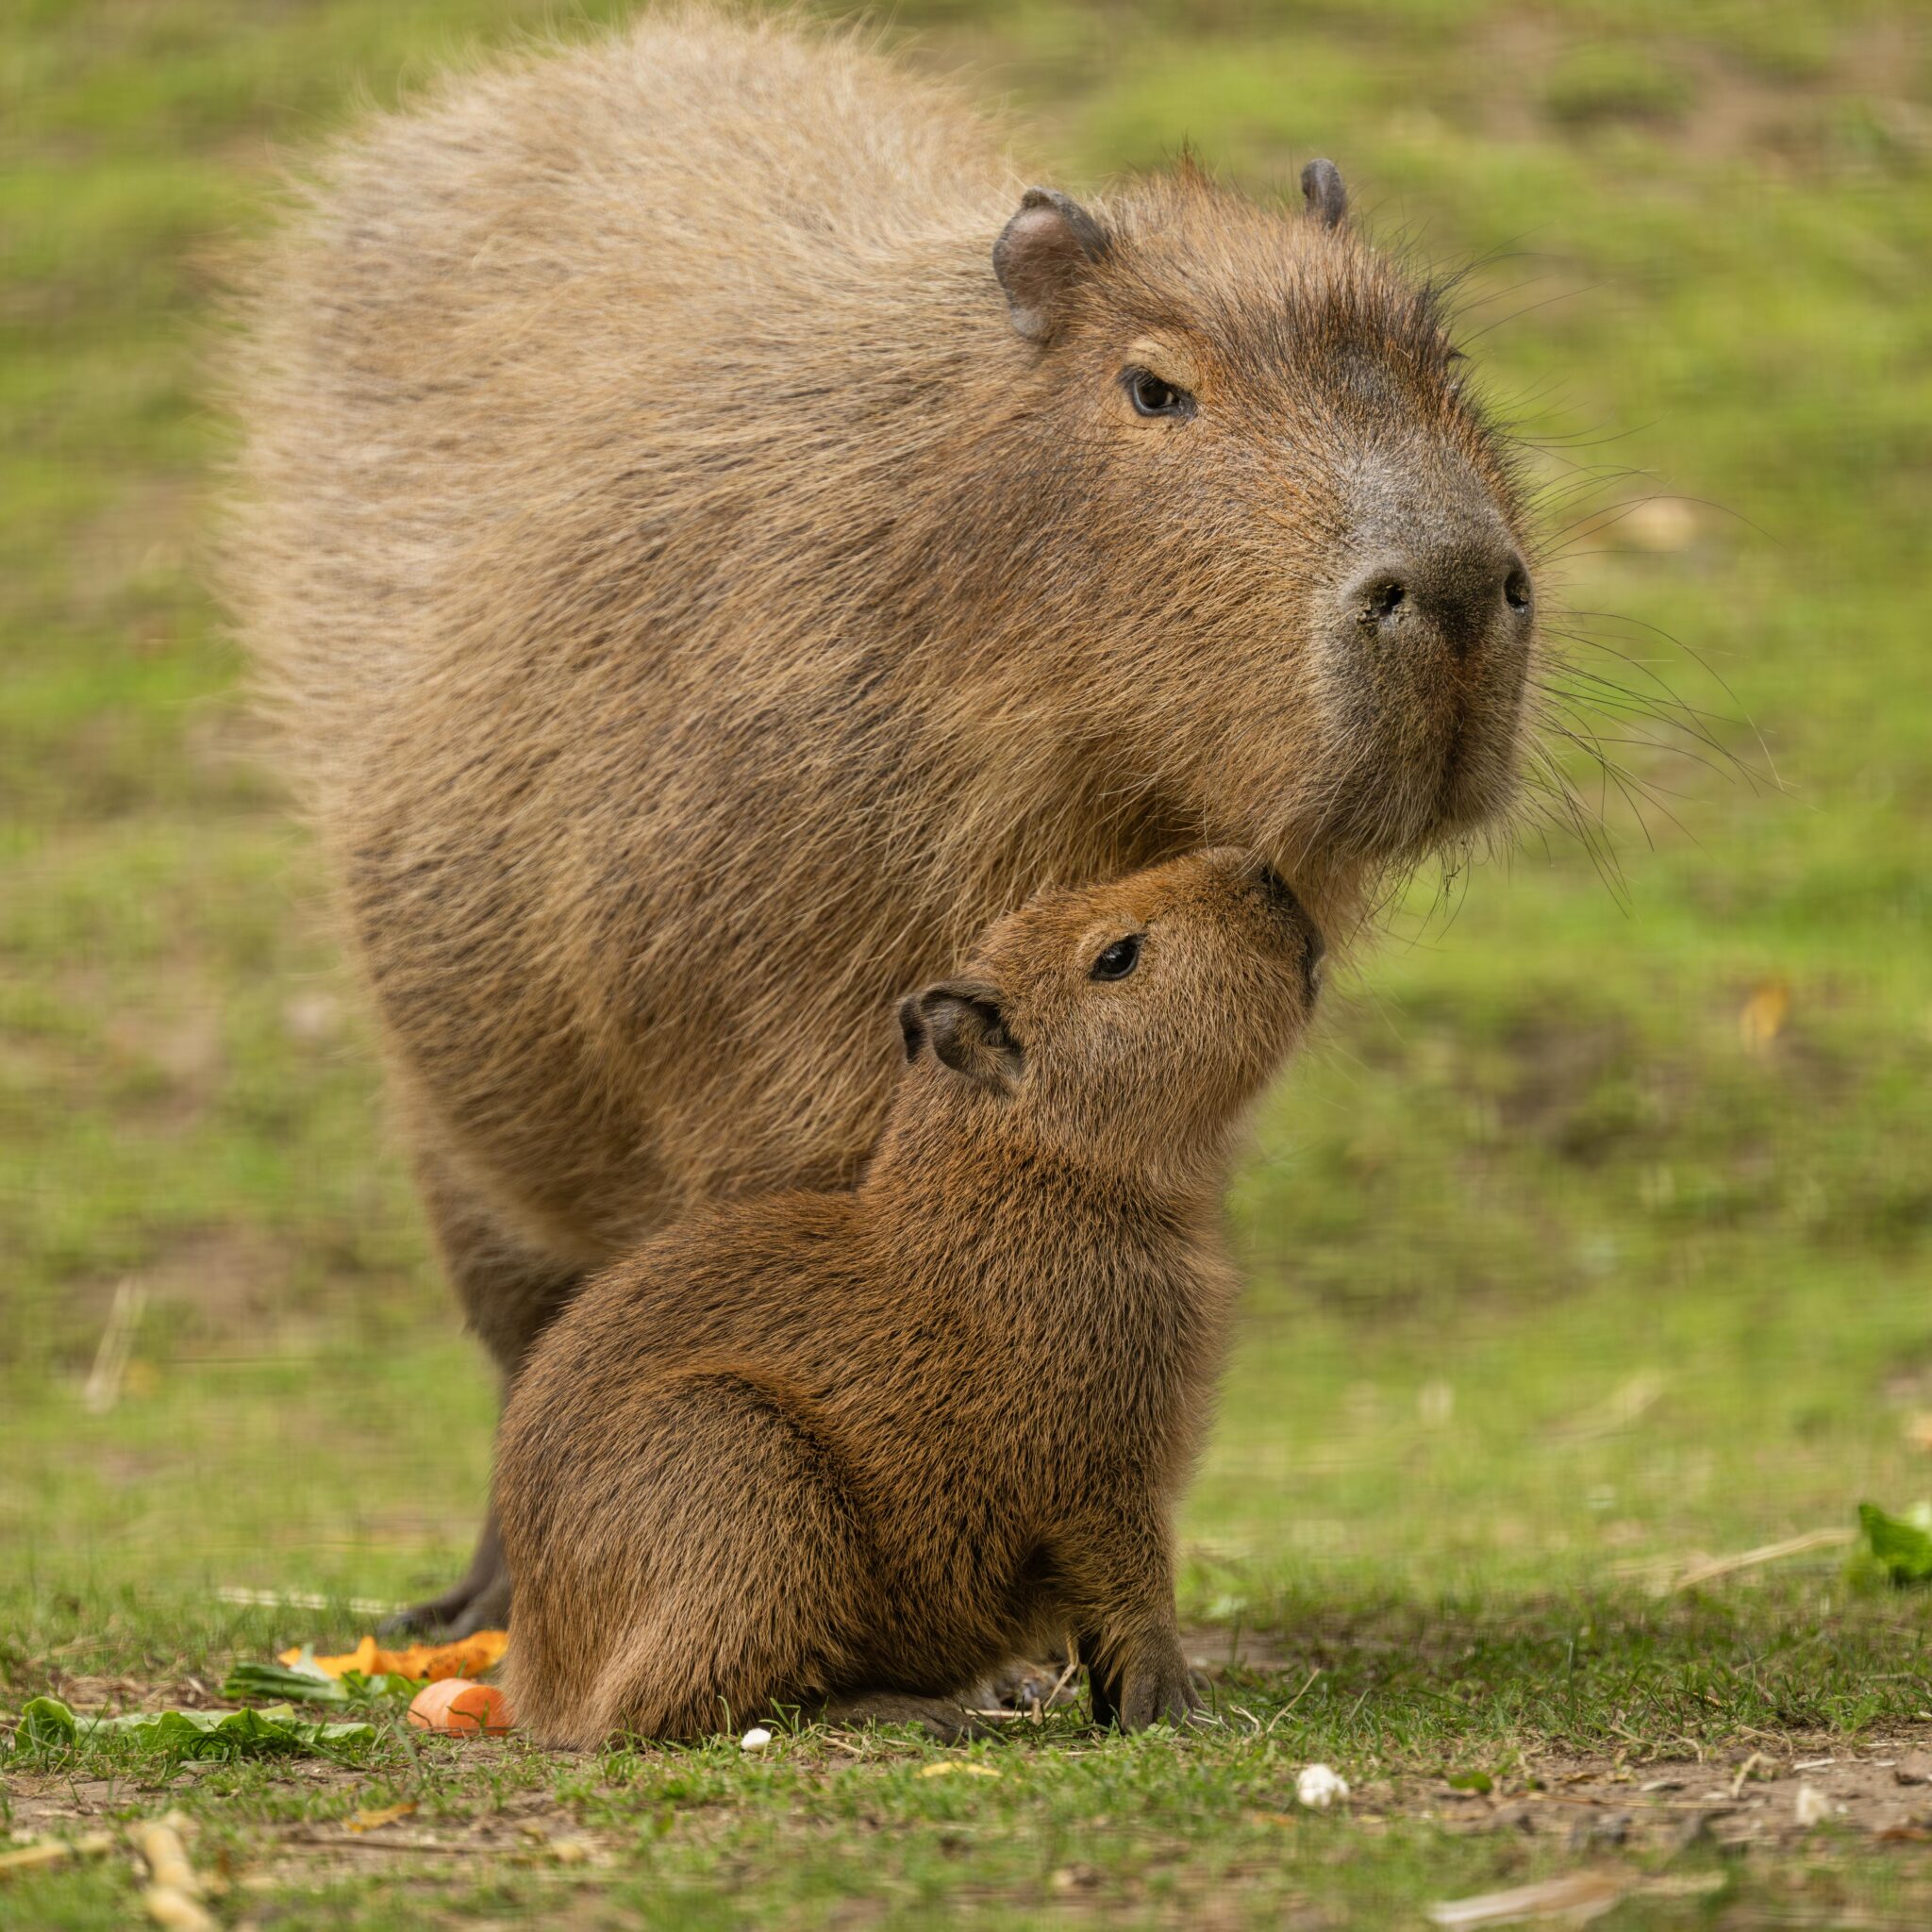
<box><xmin>0</xmin><ymin>0</ymin><xmax>1932</xmax><ymax>1631</ymax></box>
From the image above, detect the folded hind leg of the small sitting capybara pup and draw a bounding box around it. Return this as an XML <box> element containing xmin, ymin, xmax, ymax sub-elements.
<box><xmin>572</xmin><ymin>1372</ymin><xmax>875</xmax><ymax>1737</ymax></box>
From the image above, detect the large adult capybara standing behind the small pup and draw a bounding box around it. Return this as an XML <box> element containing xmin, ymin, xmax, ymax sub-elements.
<box><xmin>228</xmin><ymin>11</ymin><xmax>1536</xmax><ymax>1631</ymax></box>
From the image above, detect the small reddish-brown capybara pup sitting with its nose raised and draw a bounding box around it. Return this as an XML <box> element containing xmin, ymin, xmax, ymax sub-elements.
<box><xmin>496</xmin><ymin>850</ymin><xmax>1322</xmax><ymax>1746</ymax></box>
